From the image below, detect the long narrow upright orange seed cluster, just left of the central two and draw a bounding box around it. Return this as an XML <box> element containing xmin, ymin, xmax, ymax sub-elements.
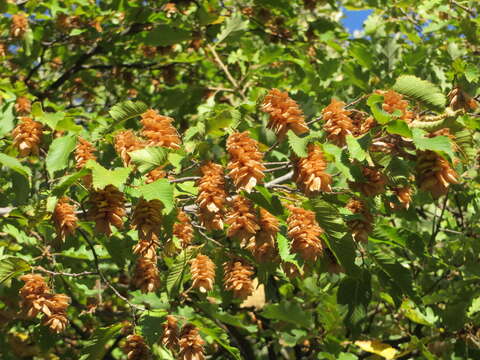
<box><xmin>196</xmin><ymin>162</ymin><xmax>227</xmax><ymax>230</ymax></box>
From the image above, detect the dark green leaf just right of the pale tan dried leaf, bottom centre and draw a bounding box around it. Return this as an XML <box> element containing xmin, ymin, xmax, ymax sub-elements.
<box><xmin>261</xmin><ymin>300</ymin><xmax>312</xmax><ymax>328</ymax></box>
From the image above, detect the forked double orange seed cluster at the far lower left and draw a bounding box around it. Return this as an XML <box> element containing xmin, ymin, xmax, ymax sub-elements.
<box><xmin>20</xmin><ymin>274</ymin><xmax>70</xmax><ymax>333</ymax></box>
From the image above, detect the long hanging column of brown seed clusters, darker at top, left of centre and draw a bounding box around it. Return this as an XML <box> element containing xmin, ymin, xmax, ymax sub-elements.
<box><xmin>132</xmin><ymin>198</ymin><xmax>163</xmax><ymax>293</ymax></box>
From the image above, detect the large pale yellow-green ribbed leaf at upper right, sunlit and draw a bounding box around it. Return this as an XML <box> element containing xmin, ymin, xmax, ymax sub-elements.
<box><xmin>393</xmin><ymin>75</ymin><xmax>446</xmax><ymax>110</ymax></box>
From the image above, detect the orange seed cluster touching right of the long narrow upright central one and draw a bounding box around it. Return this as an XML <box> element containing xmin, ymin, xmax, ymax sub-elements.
<box><xmin>226</xmin><ymin>195</ymin><xmax>260</xmax><ymax>246</ymax></box>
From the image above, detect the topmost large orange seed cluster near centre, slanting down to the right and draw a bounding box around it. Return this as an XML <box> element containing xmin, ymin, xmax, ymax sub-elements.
<box><xmin>262</xmin><ymin>89</ymin><xmax>309</xmax><ymax>139</ymax></box>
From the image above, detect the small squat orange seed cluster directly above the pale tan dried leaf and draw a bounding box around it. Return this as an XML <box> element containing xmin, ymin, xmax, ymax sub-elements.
<box><xmin>223</xmin><ymin>259</ymin><xmax>254</xmax><ymax>299</ymax></box>
